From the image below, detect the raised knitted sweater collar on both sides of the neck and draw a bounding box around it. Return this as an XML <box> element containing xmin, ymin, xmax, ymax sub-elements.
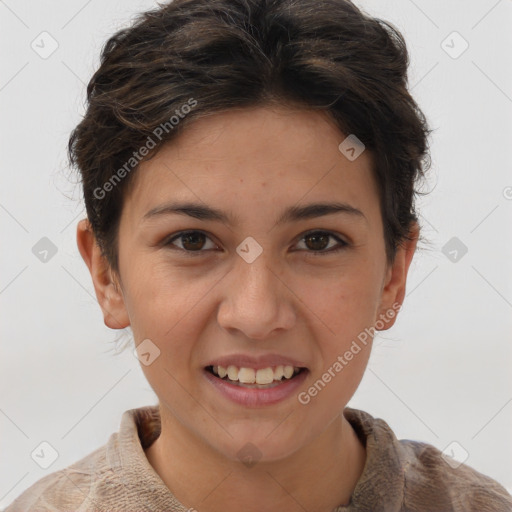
<box><xmin>107</xmin><ymin>405</ymin><xmax>404</xmax><ymax>512</ymax></box>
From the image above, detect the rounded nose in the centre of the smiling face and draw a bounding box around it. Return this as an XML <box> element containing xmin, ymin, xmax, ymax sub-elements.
<box><xmin>217</xmin><ymin>252</ymin><xmax>295</xmax><ymax>340</ymax></box>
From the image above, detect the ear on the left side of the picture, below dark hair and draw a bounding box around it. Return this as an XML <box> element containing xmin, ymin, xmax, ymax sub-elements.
<box><xmin>76</xmin><ymin>219</ymin><xmax>130</xmax><ymax>329</ymax></box>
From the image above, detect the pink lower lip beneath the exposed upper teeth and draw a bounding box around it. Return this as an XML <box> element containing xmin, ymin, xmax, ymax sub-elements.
<box><xmin>203</xmin><ymin>369</ymin><xmax>308</xmax><ymax>407</ymax></box>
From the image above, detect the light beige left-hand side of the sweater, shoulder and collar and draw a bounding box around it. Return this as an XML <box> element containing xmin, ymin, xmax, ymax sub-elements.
<box><xmin>4</xmin><ymin>406</ymin><xmax>166</xmax><ymax>512</ymax></box>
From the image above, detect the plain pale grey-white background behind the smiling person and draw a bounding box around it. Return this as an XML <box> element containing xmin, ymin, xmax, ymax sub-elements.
<box><xmin>0</xmin><ymin>0</ymin><xmax>512</xmax><ymax>507</ymax></box>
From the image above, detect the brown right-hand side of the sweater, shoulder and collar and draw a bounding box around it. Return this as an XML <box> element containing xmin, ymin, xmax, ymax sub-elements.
<box><xmin>344</xmin><ymin>408</ymin><xmax>512</xmax><ymax>512</ymax></box>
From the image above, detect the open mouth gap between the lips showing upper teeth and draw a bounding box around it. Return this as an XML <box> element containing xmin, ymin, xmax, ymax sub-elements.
<box><xmin>205</xmin><ymin>365</ymin><xmax>308</xmax><ymax>389</ymax></box>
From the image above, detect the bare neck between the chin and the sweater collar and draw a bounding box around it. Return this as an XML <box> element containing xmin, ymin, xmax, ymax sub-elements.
<box><xmin>146</xmin><ymin>406</ymin><xmax>366</xmax><ymax>512</ymax></box>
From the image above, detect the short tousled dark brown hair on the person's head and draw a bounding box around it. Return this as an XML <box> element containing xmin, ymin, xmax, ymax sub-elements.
<box><xmin>68</xmin><ymin>0</ymin><xmax>430</xmax><ymax>272</ymax></box>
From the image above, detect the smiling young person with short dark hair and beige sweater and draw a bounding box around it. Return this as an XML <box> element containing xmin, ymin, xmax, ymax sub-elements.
<box><xmin>7</xmin><ymin>0</ymin><xmax>512</xmax><ymax>512</ymax></box>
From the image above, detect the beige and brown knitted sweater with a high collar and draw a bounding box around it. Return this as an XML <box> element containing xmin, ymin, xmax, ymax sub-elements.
<box><xmin>5</xmin><ymin>406</ymin><xmax>512</xmax><ymax>512</ymax></box>
